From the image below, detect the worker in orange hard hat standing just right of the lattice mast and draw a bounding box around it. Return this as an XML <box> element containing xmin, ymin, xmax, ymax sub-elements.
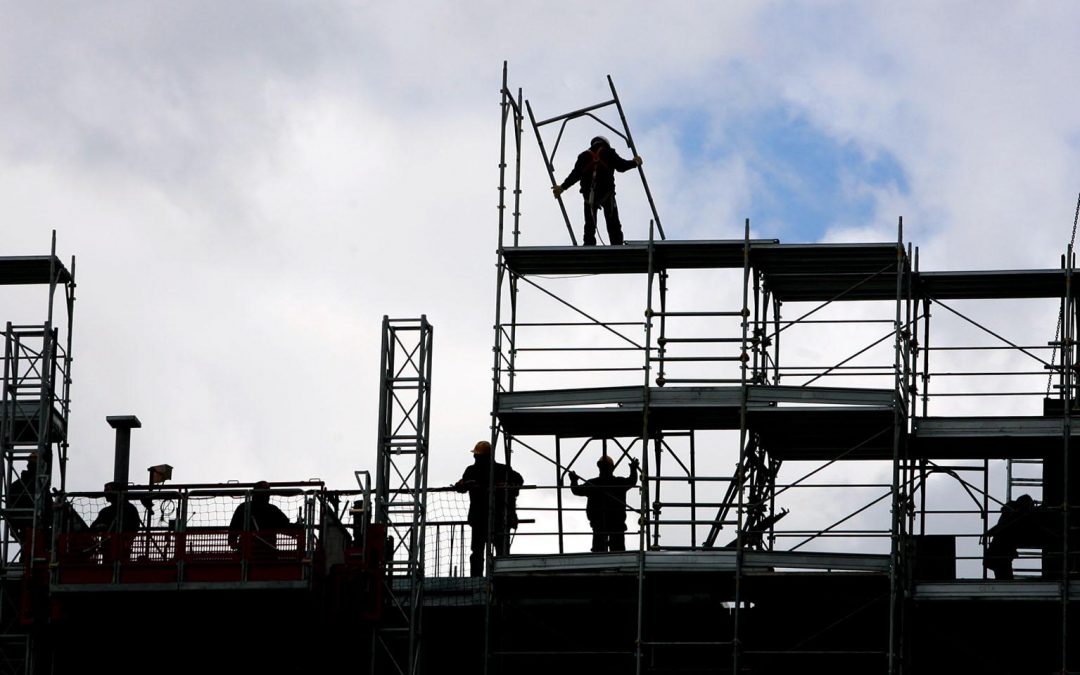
<box><xmin>454</xmin><ymin>441</ymin><xmax>524</xmax><ymax>577</ymax></box>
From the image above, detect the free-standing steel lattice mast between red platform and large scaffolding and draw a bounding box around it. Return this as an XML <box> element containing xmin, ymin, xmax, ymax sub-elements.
<box><xmin>373</xmin><ymin>316</ymin><xmax>432</xmax><ymax>675</ymax></box>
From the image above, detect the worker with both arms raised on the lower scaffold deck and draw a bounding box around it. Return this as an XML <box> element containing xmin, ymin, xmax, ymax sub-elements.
<box><xmin>570</xmin><ymin>455</ymin><xmax>638</xmax><ymax>553</ymax></box>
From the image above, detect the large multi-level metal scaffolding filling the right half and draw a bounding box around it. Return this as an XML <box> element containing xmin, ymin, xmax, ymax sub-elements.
<box><xmin>485</xmin><ymin>66</ymin><xmax>1077</xmax><ymax>674</ymax></box>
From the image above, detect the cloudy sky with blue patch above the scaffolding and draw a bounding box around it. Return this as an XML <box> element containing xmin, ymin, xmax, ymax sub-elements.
<box><xmin>0</xmin><ymin>0</ymin><xmax>1080</xmax><ymax>557</ymax></box>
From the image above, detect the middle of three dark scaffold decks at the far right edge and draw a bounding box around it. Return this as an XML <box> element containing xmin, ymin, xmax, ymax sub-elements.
<box><xmin>912</xmin><ymin>417</ymin><xmax>1080</xmax><ymax>459</ymax></box>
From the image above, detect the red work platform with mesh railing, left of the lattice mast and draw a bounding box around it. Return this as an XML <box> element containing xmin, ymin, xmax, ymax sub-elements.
<box><xmin>52</xmin><ymin>483</ymin><xmax>382</xmax><ymax>584</ymax></box>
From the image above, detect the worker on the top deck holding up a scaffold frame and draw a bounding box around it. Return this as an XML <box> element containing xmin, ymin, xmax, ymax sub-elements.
<box><xmin>551</xmin><ymin>136</ymin><xmax>642</xmax><ymax>246</ymax></box>
